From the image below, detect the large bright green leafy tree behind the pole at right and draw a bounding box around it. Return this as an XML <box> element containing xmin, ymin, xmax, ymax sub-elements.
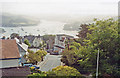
<box><xmin>77</xmin><ymin>19</ymin><xmax>120</xmax><ymax>76</ymax></box>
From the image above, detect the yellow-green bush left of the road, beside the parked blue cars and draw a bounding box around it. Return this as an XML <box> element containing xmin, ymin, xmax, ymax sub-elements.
<box><xmin>25</xmin><ymin>50</ymin><xmax>47</xmax><ymax>64</ymax></box>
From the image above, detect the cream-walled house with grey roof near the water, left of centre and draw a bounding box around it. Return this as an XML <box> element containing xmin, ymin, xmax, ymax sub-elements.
<box><xmin>23</xmin><ymin>35</ymin><xmax>43</xmax><ymax>48</ymax></box>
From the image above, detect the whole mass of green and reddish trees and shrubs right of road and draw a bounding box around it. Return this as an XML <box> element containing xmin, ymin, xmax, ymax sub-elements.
<box><xmin>61</xmin><ymin>18</ymin><xmax>120</xmax><ymax>77</ymax></box>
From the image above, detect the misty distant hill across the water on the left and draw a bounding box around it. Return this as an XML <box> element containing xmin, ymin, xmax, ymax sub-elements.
<box><xmin>1</xmin><ymin>13</ymin><xmax>39</xmax><ymax>27</ymax></box>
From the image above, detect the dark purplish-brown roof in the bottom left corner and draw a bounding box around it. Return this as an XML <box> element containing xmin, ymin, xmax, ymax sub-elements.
<box><xmin>0</xmin><ymin>67</ymin><xmax>31</xmax><ymax>78</ymax></box>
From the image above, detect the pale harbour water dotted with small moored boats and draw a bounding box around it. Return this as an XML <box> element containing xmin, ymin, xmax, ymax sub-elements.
<box><xmin>0</xmin><ymin>20</ymin><xmax>78</xmax><ymax>37</ymax></box>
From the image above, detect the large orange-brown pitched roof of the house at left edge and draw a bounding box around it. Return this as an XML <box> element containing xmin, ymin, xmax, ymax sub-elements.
<box><xmin>0</xmin><ymin>40</ymin><xmax>20</xmax><ymax>59</ymax></box>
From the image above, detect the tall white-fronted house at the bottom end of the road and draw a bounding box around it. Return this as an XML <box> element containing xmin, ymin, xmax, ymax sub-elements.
<box><xmin>54</xmin><ymin>34</ymin><xmax>74</xmax><ymax>54</ymax></box>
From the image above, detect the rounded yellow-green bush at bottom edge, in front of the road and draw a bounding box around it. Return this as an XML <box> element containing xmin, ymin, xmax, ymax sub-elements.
<box><xmin>28</xmin><ymin>66</ymin><xmax>84</xmax><ymax>78</ymax></box>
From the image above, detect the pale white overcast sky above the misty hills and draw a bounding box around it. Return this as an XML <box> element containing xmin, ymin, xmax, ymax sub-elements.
<box><xmin>0</xmin><ymin>0</ymin><xmax>119</xmax><ymax>15</ymax></box>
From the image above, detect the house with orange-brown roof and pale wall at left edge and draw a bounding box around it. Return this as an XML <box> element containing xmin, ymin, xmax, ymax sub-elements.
<box><xmin>0</xmin><ymin>39</ymin><xmax>20</xmax><ymax>68</ymax></box>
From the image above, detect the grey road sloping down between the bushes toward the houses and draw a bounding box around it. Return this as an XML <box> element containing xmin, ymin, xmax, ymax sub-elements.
<box><xmin>39</xmin><ymin>53</ymin><xmax>61</xmax><ymax>71</ymax></box>
